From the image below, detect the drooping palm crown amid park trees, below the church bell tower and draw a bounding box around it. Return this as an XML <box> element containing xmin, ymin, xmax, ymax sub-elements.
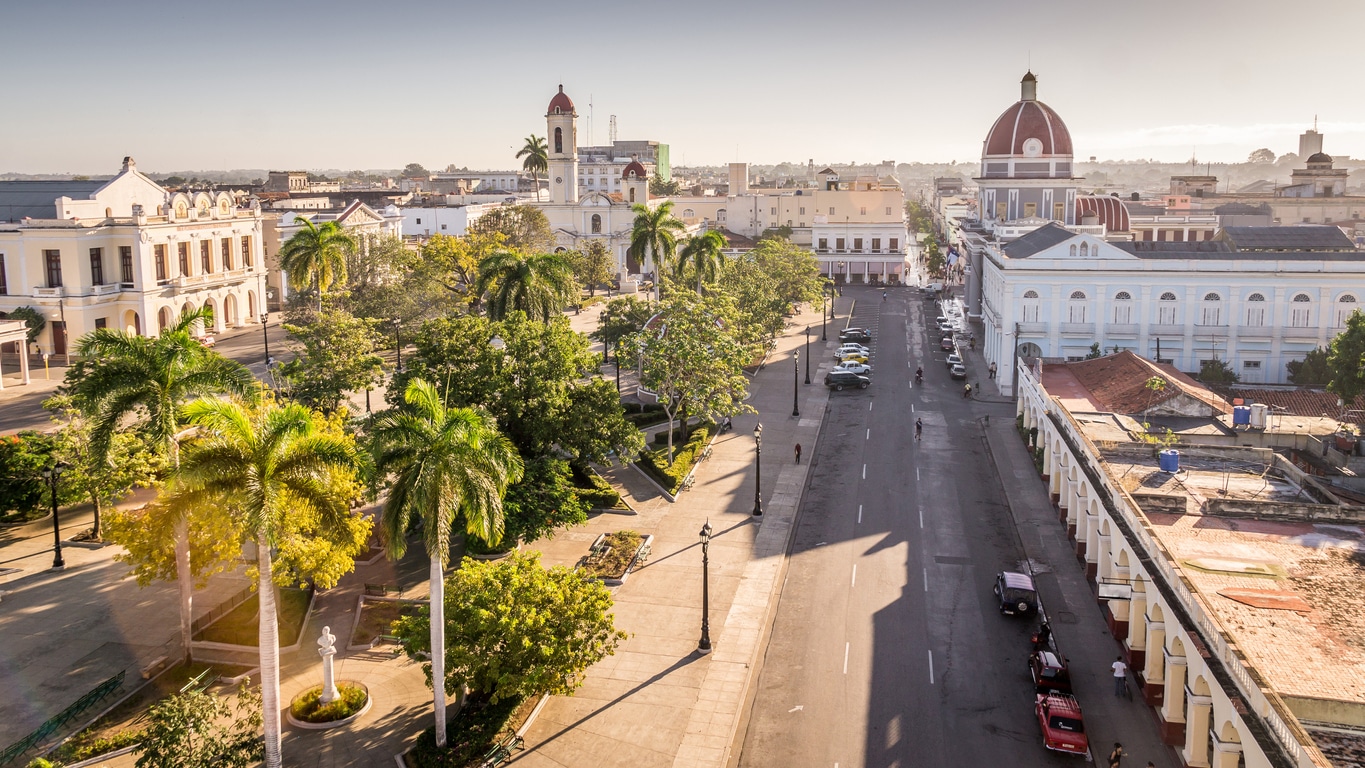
<box><xmin>474</xmin><ymin>251</ymin><xmax>579</xmax><ymax>322</ymax></box>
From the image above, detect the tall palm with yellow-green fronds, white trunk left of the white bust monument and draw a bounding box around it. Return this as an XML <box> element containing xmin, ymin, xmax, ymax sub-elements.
<box><xmin>171</xmin><ymin>397</ymin><xmax>358</xmax><ymax>768</ymax></box>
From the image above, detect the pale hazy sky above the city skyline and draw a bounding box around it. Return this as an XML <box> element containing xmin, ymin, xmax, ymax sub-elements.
<box><xmin>0</xmin><ymin>0</ymin><xmax>1365</xmax><ymax>173</ymax></box>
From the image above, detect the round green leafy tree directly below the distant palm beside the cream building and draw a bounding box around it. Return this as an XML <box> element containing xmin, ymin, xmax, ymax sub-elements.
<box><xmin>281</xmin><ymin>310</ymin><xmax>384</xmax><ymax>411</ymax></box>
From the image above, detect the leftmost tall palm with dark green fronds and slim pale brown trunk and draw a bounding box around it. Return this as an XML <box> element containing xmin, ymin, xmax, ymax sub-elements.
<box><xmin>71</xmin><ymin>307</ymin><xmax>257</xmax><ymax>659</ymax></box>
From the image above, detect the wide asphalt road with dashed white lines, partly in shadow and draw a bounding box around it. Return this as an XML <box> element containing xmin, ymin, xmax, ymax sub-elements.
<box><xmin>740</xmin><ymin>288</ymin><xmax>1081</xmax><ymax>768</ymax></box>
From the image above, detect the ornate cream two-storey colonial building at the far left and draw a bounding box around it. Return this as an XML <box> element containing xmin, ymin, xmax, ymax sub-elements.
<box><xmin>0</xmin><ymin>157</ymin><xmax>265</xmax><ymax>355</ymax></box>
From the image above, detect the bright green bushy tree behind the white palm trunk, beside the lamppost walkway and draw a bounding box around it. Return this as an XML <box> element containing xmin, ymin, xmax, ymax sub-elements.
<box><xmin>397</xmin><ymin>552</ymin><xmax>627</xmax><ymax>703</ymax></box>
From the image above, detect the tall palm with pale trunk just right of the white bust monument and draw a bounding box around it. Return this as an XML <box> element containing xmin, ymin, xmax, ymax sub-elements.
<box><xmin>373</xmin><ymin>379</ymin><xmax>521</xmax><ymax>748</ymax></box>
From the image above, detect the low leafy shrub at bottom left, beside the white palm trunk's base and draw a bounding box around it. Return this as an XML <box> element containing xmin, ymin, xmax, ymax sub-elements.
<box><xmin>134</xmin><ymin>682</ymin><xmax>265</xmax><ymax>768</ymax></box>
